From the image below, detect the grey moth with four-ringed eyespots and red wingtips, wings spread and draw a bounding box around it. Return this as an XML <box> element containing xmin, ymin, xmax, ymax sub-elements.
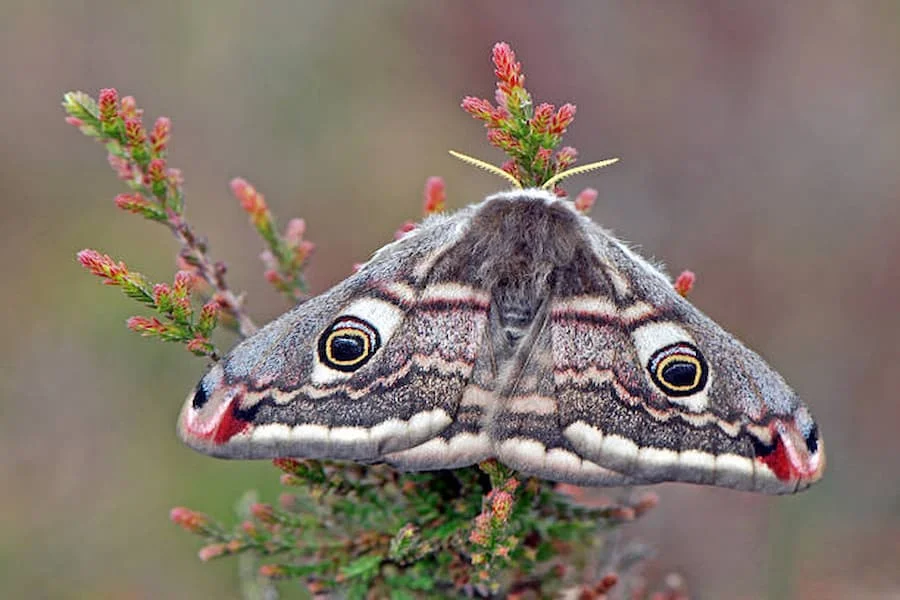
<box><xmin>178</xmin><ymin>157</ymin><xmax>825</xmax><ymax>494</ymax></box>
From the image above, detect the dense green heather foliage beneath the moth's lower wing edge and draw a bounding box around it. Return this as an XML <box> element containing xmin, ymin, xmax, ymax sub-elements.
<box><xmin>170</xmin><ymin>459</ymin><xmax>655</xmax><ymax>598</ymax></box>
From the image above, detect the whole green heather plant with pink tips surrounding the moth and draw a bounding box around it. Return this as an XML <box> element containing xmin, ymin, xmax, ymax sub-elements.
<box><xmin>63</xmin><ymin>43</ymin><xmax>693</xmax><ymax>600</ymax></box>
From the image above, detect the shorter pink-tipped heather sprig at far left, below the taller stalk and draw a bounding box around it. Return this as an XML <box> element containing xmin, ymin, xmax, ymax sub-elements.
<box><xmin>77</xmin><ymin>249</ymin><xmax>219</xmax><ymax>360</ymax></box>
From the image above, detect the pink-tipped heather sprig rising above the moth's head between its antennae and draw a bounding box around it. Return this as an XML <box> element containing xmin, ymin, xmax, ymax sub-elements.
<box><xmin>462</xmin><ymin>42</ymin><xmax>578</xmax><ymax>192</ymax></box>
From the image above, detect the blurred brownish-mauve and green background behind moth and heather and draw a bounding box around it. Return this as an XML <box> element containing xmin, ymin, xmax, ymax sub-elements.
<box><xmin>0</xmin><ymin>0</ymin><xmax>900</xmax><ymax>599</ymax></box>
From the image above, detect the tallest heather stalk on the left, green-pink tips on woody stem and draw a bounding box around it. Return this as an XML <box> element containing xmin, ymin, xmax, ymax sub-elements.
<box><xmin>62</xmin><ymin>88</ymin><xmax>256</xmax><ymax>336</ymax></box>
